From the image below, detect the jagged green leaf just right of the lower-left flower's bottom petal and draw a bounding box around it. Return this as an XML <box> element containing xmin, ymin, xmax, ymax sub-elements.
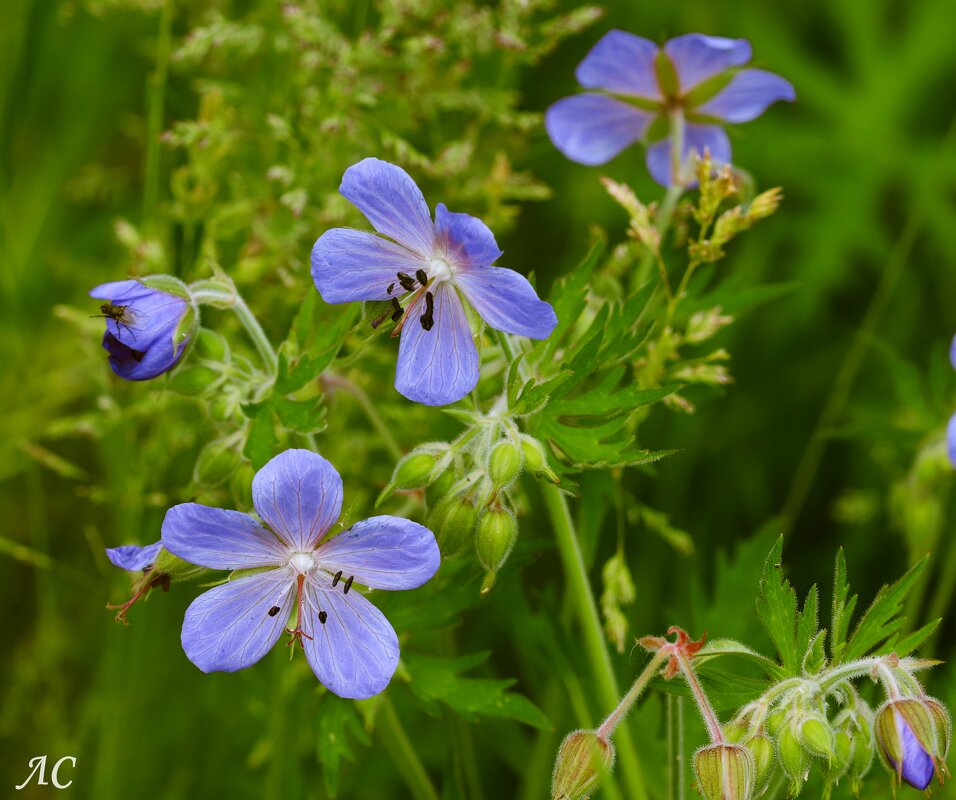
<box><xmin>403</xmin><ymin>652</ymin><xmax>551</xmax><ymax>731</ymax></box>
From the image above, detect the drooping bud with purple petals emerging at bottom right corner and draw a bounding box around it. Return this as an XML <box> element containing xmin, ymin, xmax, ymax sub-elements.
<box><xmin>875</xmin><ymin>697</ymin><xmax>947</xmax><ymax>789</ymax></box>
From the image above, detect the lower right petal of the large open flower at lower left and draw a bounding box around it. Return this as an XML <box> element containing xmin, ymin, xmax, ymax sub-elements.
<box><xmin>302</xmin><ymin>583</ymin><xmax>399</xmax><ymax>700</ymax></box>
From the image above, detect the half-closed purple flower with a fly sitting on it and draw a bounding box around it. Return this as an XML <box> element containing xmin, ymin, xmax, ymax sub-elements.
<box><xmin>90</xmin><ymin>275</ymin><xmax>196</xmax><ymax>381</ymax></box>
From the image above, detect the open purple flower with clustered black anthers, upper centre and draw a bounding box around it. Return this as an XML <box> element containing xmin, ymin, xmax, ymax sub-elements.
<box><xmin>312</xmin><ymin>158</ymin><xmax>557</xmax><ymax>406</ymax></box>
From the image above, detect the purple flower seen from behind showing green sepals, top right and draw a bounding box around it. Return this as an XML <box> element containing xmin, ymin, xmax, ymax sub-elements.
<box><xmin>545</xmin><ymin>30</ymin><xmax>796</xmax><ymax>186</ymax></box>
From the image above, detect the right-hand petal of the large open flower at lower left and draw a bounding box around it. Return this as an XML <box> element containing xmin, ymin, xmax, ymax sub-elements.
<box><xmin>315</xmin><ymin>516</ymin><xmax>441</xmax><ymax>589</ymax></box>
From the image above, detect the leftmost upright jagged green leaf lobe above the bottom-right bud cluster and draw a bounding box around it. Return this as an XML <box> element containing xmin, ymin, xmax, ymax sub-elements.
<box><xmin>757</xmin><ymin>536</ymin><xmax>818</xmax><ymax>675</ymax></box>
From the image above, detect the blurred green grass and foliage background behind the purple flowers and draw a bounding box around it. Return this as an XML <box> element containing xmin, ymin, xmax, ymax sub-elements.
<box><xmin>0</xmin><ymin>0</ymin><xmax>956</xmax><ymax>800</ymax></box>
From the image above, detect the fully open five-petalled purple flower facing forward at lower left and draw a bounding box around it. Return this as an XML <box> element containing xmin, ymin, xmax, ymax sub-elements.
<box><xmin>162</xmin><ymin>450</ymin><xmax>439</xmax><ymax>699</ymax></box>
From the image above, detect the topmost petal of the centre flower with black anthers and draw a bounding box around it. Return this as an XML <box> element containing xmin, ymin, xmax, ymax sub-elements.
<box><xmin>339</xmin><ymin>158</ymin><xmax>434</xmax><ymax>257</ymax></box>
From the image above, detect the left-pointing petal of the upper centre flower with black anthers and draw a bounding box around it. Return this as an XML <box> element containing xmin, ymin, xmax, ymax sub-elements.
<box><xmin>312</xmin><ymin>228</ymin><xmax>427</xmax><ymax>303</ymax></box>
